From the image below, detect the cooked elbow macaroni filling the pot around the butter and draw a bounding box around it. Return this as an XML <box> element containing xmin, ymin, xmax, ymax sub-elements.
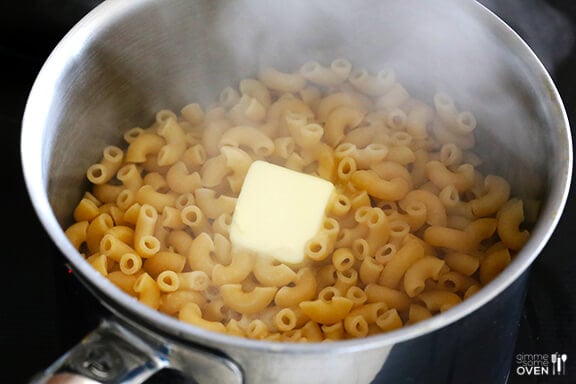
<box><xmin>65</xmin><ymin>58</ymin><xmax>529</xmax><ymax>342</ymax></box>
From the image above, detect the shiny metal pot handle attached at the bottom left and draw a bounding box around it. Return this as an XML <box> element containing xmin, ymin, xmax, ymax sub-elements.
<box><xmin>30</xmin><ymin>320</ymin><xmax>243</xmax><ymax>384</ymax></box>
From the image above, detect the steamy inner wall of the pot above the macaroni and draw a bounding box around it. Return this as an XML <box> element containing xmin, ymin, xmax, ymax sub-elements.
<box><xmin>43</xmin><ymin>0</ymin><xmax>560</xmax><ymax>226</ymax></box>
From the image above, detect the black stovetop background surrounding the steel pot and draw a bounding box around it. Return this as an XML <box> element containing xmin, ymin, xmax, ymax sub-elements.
<box><xmin>0</xmin><ymin>0</ymin><xmax>576</xmax><ymax>384</ymax></box>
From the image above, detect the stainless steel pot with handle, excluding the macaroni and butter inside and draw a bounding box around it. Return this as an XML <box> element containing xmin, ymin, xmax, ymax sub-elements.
<box><xmin>21</xmin><ymin>0</ymin><xmax>572</xmax><ymax>384</ymax></box>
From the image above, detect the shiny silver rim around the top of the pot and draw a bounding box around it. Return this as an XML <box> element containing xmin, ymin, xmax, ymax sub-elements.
<box><xmin>20</xmin><ymin>0</ymin><xmax>573</xmax><ymax>354</ymax></box>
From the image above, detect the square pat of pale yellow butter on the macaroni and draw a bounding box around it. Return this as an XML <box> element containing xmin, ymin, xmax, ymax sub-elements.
<box><xmin>230</xmin><ymin>160</ymin><xmax>334</xmax><ymax>264</ymax></box>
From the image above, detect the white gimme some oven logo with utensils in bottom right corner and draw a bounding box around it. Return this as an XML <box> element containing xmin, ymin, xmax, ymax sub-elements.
<box><xmin>514</xmin><ymin>353</ymin><xmax>568</xmax><ymax>376</ymax></box>
